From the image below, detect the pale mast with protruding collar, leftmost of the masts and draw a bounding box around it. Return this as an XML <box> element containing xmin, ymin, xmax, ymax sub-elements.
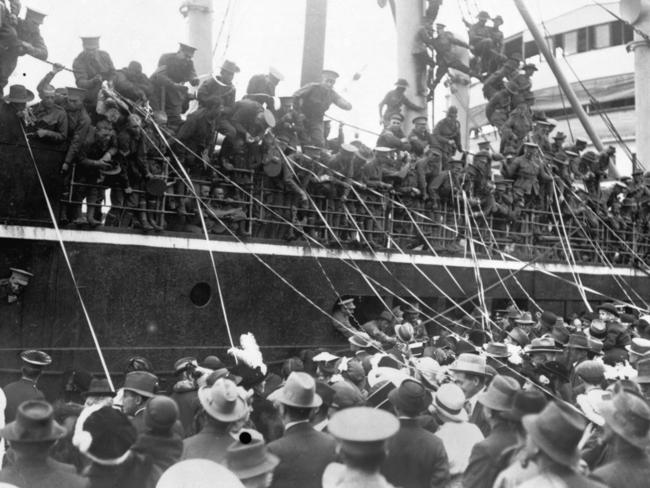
<box><xmin>180</xmin><ymin>0</ymin><xmax>213</xmax><ymax>79</ymax></box>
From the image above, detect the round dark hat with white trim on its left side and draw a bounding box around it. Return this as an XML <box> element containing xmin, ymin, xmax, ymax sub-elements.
<box><xmin>72</xmin><ymin>404</ymin><xmax>137</xmax><ymax>466</ymax></box>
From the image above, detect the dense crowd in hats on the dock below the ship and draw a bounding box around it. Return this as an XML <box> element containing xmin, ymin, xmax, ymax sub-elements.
<box><xmin>0</xmin><ymin>299</ymin><xmax>650</xmax><ymax>488</ymax></box>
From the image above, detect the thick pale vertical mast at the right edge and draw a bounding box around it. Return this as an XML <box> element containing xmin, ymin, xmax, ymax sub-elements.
<box><xmin>619</xmin><ymin>0</ymin><xmax>650</xmax><ymax>169</ymax></box>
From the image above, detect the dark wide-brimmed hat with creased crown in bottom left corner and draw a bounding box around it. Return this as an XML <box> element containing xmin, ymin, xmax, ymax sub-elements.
<box><xmin>0</xmin><ymin>400</ymin><xmax>66</xmax><ymax>443</ymax></box>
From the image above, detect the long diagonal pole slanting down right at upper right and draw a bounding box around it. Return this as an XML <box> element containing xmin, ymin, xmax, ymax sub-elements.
<box><xmin>514</xmin><ymin>0</ymin><xmax>619</xmax><ymax>178</ymax></box>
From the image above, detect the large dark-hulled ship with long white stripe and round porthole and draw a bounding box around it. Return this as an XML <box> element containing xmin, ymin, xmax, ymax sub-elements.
<box><xmin>0</xmin><ymin>0</ymin><xmax>650</xmax><ymax>391</ymax></box>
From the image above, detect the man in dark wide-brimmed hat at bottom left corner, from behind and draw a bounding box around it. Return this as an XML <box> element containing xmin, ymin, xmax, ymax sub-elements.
<box><xmin>0</xmin><ymin>400</ymin><xmax>87</xmax><ymax>488</ymax></box>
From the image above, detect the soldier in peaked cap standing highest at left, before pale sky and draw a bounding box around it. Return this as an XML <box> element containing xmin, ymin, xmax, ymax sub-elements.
<box><xmin>72</xmin><ymin>36</ymin><xmax>115</xmax><ymax>117</ymax></box>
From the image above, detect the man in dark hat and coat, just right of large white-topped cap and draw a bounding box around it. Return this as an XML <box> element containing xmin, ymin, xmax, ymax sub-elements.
<box><xmin>382</xmin><ymin>379</ymin><xmax>449</xmax><ymax>488</ymax></box>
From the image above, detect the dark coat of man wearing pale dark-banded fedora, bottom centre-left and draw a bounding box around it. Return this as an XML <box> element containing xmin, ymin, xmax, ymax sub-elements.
<box><xmin>267</xmin><ymin>422</ymin><xmax>336</xmax><ymax>488</ymax></box>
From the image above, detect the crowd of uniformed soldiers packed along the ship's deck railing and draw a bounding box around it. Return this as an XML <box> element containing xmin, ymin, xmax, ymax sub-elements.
<box><xmin>0</xmin><ymin>5</ymin><xmax>650</xmax><ymax>258</ymax></box>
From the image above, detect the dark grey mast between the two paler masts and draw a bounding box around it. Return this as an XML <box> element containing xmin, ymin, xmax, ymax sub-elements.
<box><xmin>300</xmin><ymin>0</ymin><xmax>327</xmax><ymax>86</ymax></box>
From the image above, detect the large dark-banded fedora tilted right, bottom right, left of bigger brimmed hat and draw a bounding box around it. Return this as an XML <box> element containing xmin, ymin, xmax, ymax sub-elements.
<box><xmin>521</xmin><ymin>401</ymin><xmax>586</xmax><ymax>468</ymax></box>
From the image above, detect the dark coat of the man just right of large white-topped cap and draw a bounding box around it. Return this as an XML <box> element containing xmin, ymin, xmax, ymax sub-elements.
<box><xmin>381</xmin><ymin>418</ymin><xmax>449</xmax><ymax>488</ymax></box>
